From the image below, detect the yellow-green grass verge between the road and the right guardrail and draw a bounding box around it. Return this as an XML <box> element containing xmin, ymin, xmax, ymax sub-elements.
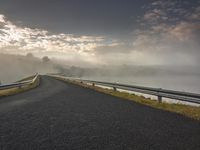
<box><xmin>56</xmin><ymin>77</ymin><xmax>200</xmax><ymax>121</ymax></box>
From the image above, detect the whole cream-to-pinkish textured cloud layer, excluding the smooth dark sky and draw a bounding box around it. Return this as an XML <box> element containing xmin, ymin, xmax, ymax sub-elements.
<box><xmin>0</xmin><ymin>0</ymin><xmax>200</xmax><ymax>65</ymax></box>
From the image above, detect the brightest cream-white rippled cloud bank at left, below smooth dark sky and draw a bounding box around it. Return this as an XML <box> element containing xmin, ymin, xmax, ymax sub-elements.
<box><xmin>0</xmin><ymin>15</ymin><xmax>104</xmax><ymax>55</ymax></box>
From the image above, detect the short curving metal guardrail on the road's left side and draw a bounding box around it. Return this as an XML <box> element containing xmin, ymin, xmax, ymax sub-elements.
<box><xmin>0</xmin><ymin>73</ymin><xmax>39</xmax><ymax>90</ymax></box>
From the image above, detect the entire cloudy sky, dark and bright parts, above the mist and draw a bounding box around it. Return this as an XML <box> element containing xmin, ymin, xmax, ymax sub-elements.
<box><xmin>0</xmin><ymin>0</ymin><xmax>200</xmax><ymax>66</ymax></box>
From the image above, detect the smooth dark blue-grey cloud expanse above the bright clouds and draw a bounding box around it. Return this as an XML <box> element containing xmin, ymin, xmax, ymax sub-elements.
<box><xmin>0</xmin><ymin>0</ymin><xmax>149</xmax><ymax>36</ymax></box>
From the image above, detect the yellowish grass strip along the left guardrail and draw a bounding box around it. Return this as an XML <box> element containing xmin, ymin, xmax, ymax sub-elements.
<box><xmin>0</xmin><ymin>76</ymin><xmax>40</xmax><ymax>97</ymax></box>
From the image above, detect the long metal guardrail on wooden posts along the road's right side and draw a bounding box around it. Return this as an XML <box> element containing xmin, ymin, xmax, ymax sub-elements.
<box><xmin>54</xmin><ymin>75</ymin><xmax>200</xmax><ymax>104</ymax></box>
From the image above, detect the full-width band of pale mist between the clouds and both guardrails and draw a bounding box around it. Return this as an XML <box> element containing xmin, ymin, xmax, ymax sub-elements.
<box><xmin>0</xmin><ymin>54</ymin><xmax>200</xmax><ymax>93</ymax></box>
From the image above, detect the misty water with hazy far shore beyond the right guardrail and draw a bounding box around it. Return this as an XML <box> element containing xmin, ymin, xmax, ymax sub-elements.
<box><xmin>59</xmin><ymin>65</ymin><xmax>200</xmax><ymax>93</ymax></box>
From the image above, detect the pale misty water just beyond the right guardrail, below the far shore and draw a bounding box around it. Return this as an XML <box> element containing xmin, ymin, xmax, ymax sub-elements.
<box><xmin>83</xmin><ymin>75</ymin><xmax>200</xmax><ymax>93</ymax></box>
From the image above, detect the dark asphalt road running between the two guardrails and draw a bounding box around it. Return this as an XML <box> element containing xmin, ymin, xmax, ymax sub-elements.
<box><xmin>0</xmin><ymin>76</ymin><xmax>200</xmax><ymax>150</ymax></box>
